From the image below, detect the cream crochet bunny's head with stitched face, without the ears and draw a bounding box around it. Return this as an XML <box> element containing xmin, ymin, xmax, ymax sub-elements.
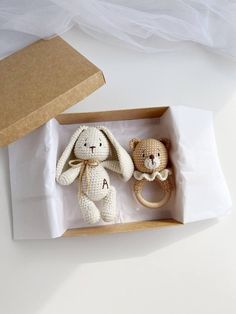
<box><xmin>74</xmin><ymin>127</ymin><xmax>110</xmax><ymax>161</ymax></box>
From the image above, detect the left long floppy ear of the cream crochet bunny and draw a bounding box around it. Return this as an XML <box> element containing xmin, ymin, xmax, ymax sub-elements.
<box><xmin>56</xmin><ymin>126</ymin><xmax>88</xmax><ymax>181</ymax></box>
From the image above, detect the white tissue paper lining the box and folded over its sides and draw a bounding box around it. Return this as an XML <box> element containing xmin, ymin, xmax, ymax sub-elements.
<box><xmin>9</xmin><ymin>106</ymin><xmax>231</xmax><ymax>239</ymax></box>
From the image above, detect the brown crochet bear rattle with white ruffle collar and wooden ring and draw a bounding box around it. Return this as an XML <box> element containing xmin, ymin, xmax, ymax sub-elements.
<box><xmin>129</xmin><ymin>138</ymin><xmax>172</xmax><ymax>208</ymax></box>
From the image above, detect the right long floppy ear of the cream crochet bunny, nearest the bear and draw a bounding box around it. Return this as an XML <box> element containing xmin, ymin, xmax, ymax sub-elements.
<box><xmin>98</xmin><ymin>126</ymin><xmax>134</xmax><ymax>181</ymax></box>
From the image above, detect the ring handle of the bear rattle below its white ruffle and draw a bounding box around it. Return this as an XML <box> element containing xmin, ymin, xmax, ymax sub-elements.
<box><xmin>134</xmin><ymin>180</ymin><xmax>171</xmax><ymax>208</ymax></box>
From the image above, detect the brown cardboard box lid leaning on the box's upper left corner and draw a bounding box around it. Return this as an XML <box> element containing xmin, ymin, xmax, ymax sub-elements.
<box><xmin>0</xmin><ymin>37</ymin><xmax>105</xmax><ymax>146</ymax></box>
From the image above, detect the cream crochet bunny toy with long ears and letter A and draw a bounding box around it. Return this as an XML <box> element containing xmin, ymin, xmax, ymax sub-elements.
<box><xmin>56</xmin><ymin>126</ymin><xmax>134</xmax><ymax>224</ymax></box>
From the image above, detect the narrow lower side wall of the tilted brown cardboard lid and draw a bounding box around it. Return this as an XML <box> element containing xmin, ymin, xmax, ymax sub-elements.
<box><xmin>0</xmin><ymin>70</ymin><xmax>105</xmax><ymax>147</ymax></box>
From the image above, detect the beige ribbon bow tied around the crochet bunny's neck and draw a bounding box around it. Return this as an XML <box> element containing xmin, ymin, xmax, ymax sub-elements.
<box><xmin>68</xmin><ymin>159</ymin><xmax>99</xmax><ymax>195</ymax></box>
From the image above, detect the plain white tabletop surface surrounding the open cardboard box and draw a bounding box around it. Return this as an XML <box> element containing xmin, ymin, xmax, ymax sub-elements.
<box><xmin>0</xmin><ymin>29</ymin><xmax>236</xmax><ymax>314</ymax></box>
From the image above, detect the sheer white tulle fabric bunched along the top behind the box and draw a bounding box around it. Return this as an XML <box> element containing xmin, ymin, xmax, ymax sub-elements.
<box><xmin>0</xmin><ymin>0</ymin><xmax>236</xmax><ymax>57</ymax></box>
